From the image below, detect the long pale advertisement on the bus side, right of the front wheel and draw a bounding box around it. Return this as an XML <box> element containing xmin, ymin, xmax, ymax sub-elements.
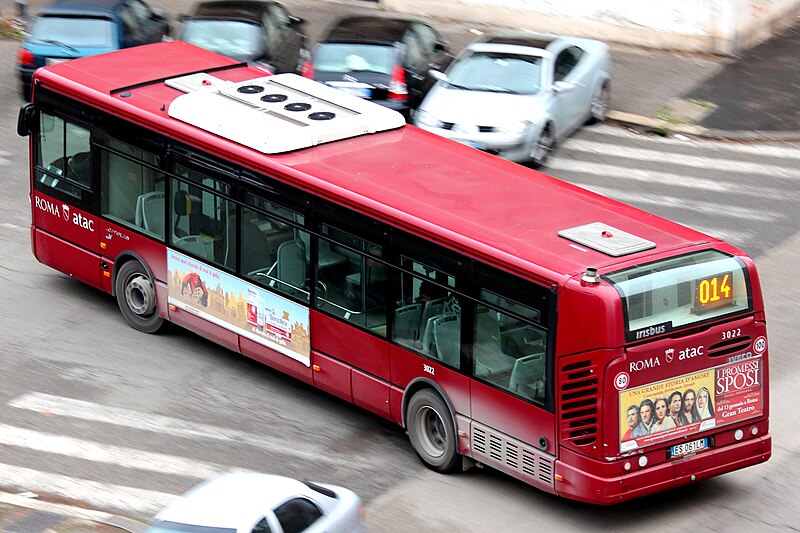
<box><xmin>167</xmin><ymin>250</ymin><xmax>311</xmax><ymax>366</ymax></box>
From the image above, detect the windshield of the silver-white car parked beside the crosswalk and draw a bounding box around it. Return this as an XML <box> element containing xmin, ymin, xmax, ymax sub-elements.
<box><xmin>447</xmin><ymin>52</ymin><xmax>542</xmax><ymax>94</ymax></box>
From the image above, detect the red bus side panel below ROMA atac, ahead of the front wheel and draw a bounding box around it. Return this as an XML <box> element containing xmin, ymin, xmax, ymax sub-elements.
<box><xmin>33</xmin><ymin>229</ymin><xmax>103</xmax><ymax>289</ymax></box>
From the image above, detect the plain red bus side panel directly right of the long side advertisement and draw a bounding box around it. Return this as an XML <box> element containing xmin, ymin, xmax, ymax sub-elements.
<box><xmin>311</xmin><ymin>311</ymin><xmax>389</xmax><ymax>381</ymax></box>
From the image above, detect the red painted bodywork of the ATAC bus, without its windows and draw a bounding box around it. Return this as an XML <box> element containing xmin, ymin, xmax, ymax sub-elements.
<box><xmin>21</xmin><ymin>42</ymin><xmax>771</xmax><ymax>504</ymax></box>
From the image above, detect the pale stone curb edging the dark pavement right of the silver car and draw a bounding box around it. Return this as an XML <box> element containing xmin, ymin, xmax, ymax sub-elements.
<box><xmin>606</xmin><ymin>111</ymin><xmax>800</xmax><ymax>142</ymax></box>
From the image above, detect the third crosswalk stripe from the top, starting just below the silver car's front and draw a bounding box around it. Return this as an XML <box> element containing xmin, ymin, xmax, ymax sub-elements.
<box><xmin>548</xmin><ymin>157</ymin><xmax>800</xmax><ymax>203</ymax></box>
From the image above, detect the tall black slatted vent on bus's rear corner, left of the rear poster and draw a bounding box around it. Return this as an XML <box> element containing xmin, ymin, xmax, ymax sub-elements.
<box><xmin>559</xmin><ymin>361</ymin><xmax>598</xmax><ymax>446</ymax></box>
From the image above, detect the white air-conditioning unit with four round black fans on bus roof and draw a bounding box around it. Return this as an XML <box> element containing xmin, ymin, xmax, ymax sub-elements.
<box><xmin>165</xmin><ymin>73</ymin><xmax>405</xmax><ymax>154</ymax></box>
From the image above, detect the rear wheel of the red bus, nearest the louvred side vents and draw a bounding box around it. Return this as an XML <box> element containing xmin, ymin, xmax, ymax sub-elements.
<box><xmin>406</xmin><ymin>389</ymin><xmax>459</xmax><ymax>473</ymax></box>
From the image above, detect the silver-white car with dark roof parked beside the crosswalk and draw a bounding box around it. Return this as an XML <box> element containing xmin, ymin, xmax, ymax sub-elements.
<box><xmin>414</xmin><ymin>34</ymin><xmax>611</xmax><ymax>166</ymax></box>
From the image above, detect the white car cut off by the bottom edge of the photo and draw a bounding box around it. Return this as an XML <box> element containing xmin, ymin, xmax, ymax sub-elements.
<box><xmin>146</xmin><ymin>472</ymin><xmax>366</xmax><ymax>533</ymax></box>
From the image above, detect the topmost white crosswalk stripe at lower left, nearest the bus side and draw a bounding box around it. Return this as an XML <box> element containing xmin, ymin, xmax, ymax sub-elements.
<box><xmin>8</xmin><ymin>392</ymin><xmax>346</xmax><ymax>464</ymax></box>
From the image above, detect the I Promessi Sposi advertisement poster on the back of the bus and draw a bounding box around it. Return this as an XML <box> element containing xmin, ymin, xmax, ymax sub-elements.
<box><xmin>619</xmin><ymin>357</ymin><xmax>763</xmax><ymax>453</ymax></box>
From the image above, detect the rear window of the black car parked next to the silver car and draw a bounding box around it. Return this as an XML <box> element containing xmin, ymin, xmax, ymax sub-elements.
<box><xmin>314</xmin><ymin>43</ymin><xmax>394</xmax><ymax>75</ymax></box>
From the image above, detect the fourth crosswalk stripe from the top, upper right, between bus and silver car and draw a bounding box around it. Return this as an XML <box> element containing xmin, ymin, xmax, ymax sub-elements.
<box><xmin>573</xmin><ymin>182</ymin><xmax>782</xmax><ymax>221</ymax></box>
